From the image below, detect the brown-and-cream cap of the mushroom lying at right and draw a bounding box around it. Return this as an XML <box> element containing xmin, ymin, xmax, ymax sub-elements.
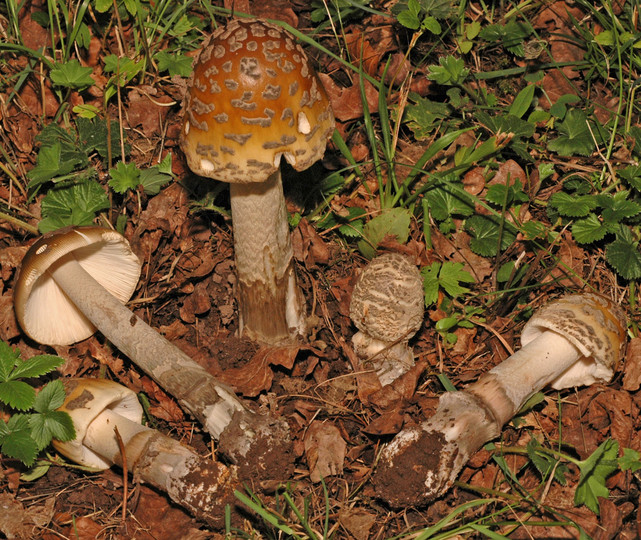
<box><xmin>521</xmin><ymin>293</ymin><xmax>627</xmax><ymax>390</ymax></box>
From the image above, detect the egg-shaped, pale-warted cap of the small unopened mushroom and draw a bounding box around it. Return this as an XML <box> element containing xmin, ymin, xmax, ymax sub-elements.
<box><xmin>349</xmin><ymin>253</ymin><xmax>425</xmax><ymax>343</ymax></box>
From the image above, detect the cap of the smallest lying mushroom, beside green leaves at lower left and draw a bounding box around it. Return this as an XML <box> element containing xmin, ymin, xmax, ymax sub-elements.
<box><xmin>52</xmin><ymin>379</ymin><xmax>143</xmax><ymax>469</ymax></box>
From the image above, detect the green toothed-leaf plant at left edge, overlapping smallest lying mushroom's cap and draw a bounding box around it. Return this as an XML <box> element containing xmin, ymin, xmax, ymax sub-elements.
<box><xmin>0</xmin><ymin>341</ymin><xmax>76</xmax><ymax>467</ymax></box>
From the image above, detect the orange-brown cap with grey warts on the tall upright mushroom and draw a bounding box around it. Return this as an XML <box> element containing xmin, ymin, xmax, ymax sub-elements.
<box><xmin>180</xmin><ymin>19</ymin><xmax>334</xmax><ymax>183</ymax></box>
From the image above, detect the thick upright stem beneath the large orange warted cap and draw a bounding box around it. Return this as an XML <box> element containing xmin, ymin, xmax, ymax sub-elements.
<box><xmin>230</xmin><ymin>169</ymin><xmax>305</xmax><ymax>344</ymax></box>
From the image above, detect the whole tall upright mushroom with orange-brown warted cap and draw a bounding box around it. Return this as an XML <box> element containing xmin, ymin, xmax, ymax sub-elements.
<box><xmin>180</xmin><ymin>19</ymin><xmax>334</xmax><ymax>344</ymax></box>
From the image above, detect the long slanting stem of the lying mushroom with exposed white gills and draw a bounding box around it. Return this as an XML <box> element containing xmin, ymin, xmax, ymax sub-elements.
<box><xmin>49</xmin><ymin>254</ymin><xmax>244</xmax><ymax>439</ymax></box>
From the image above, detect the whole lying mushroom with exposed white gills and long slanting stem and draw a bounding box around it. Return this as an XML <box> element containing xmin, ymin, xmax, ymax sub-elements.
<box><xmin>14</xmin><ymin>227</ymin><xmax>289</xmax><ymax>474</ymax></box>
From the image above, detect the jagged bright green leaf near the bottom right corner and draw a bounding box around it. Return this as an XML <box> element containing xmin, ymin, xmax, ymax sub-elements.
<box><xmin>574</xmin><ymin>439</ymin><xmax>619</xmax><ymax>515</ymax></box>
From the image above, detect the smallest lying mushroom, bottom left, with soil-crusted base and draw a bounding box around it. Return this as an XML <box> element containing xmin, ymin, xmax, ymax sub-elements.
<box><xmin>53</xmin><ymin>379</ymin><xmax>238</xmax><ymax>526</ymax></box>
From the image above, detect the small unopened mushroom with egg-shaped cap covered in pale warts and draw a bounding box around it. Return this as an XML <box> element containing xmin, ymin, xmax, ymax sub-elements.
<box><xmin>349</xmin><ymin>253</ymin><xmax>425</xmax><ymax>386</ymax></box>
